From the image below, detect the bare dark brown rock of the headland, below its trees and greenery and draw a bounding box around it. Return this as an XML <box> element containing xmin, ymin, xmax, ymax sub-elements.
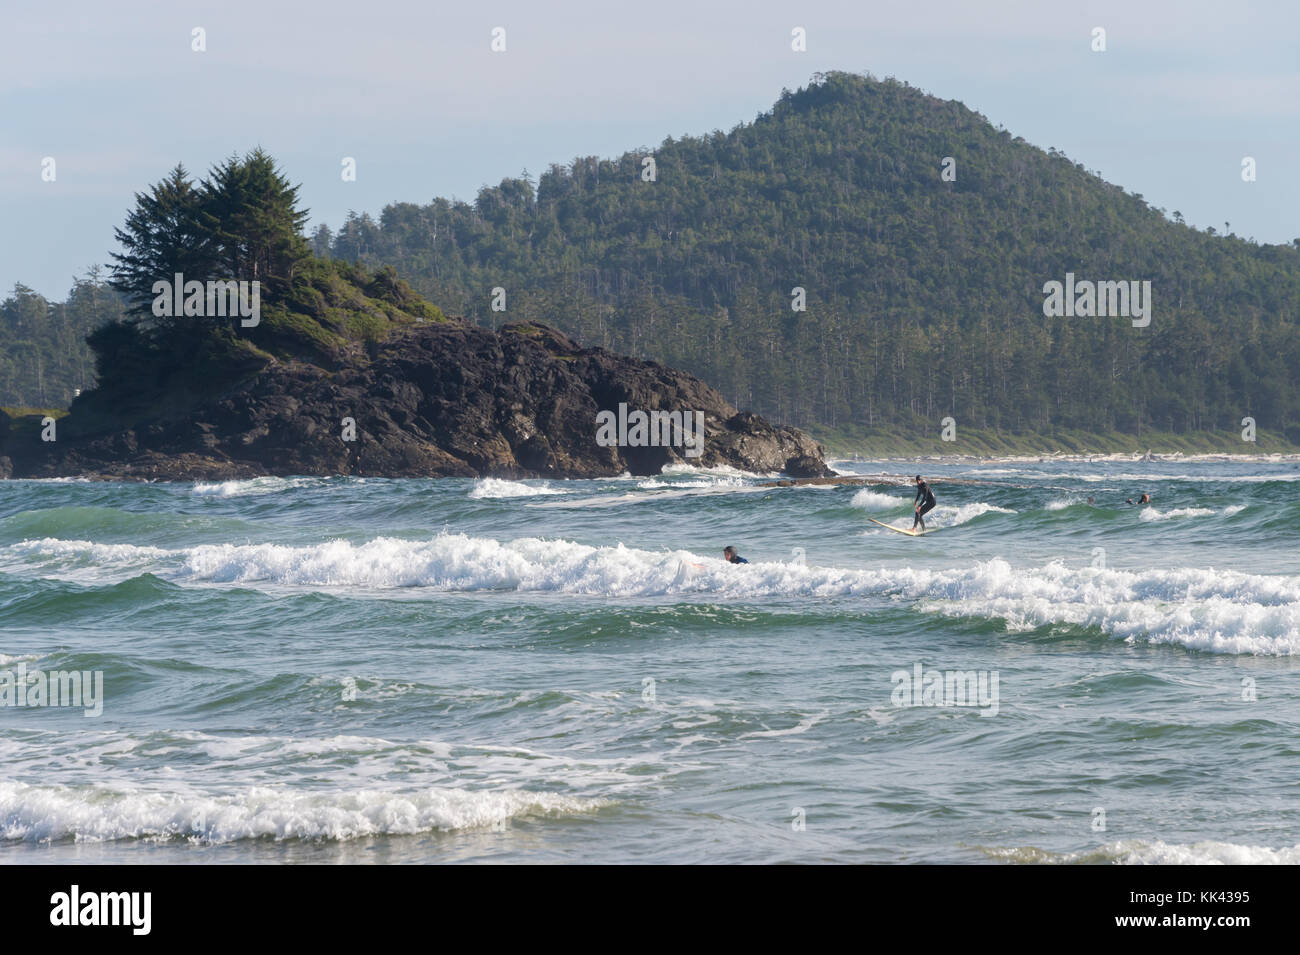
<box><xmin>0</xmin><ymin>321</ymin><xmax>831</xmax><ymax>481</ymax></box>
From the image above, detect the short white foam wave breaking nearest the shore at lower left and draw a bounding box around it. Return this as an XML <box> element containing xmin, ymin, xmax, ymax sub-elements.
<box><xmin>0</xmin><ymin>782</ymin><xmax>607</xmax><ymax>843</ymax></box>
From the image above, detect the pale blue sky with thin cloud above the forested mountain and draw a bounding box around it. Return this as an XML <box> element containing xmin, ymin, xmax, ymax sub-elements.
<box><xmin>0</xmin><ymin>0</ymin><xmax>1300</xmax><ymax>300</ymax></box>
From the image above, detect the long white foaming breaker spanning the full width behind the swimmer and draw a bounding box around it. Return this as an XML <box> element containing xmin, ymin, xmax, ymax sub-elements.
<box><xmin>10</xmin><ymin>535</ymin><xmax>1300</xmax><ymax>655</ymax></box>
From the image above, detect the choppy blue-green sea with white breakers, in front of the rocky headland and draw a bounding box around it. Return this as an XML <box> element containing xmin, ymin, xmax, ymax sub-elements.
<box><xmin>0</xmin><ymin>460</ymin><xmax>1300</xmax><ymax>863</ymax></box>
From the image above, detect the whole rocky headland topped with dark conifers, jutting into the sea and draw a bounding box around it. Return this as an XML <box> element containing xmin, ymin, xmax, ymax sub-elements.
<box><xmin>0</xmin><ymin>149</ymin><xmax>831</xmax><ymax>481</ymax></box>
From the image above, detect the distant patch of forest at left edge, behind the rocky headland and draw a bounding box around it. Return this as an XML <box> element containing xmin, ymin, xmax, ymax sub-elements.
<box><xmin>0</xmin><ymin>266</ymin><xmax>124</xmax><ymax>408</ymax></box>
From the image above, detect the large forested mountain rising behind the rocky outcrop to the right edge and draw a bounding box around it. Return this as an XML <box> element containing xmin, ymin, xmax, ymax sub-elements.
<box><xmin>312</xmin><ymin>73</ymin><xmax>1300</xmax><ymax>439</ymax></box>
